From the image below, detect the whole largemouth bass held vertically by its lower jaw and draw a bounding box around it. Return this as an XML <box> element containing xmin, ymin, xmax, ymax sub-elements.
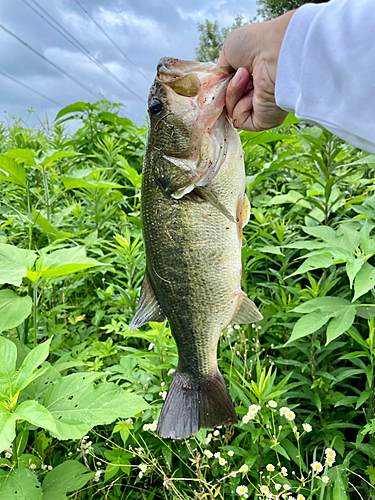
<box><xmin>130</xmin><ymin>58</ymin><xmax>262</xmax><ymax>439</ymax></box>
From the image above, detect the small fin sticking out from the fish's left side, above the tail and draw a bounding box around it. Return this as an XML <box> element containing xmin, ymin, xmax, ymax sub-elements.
<box><xmin>129</xmin><ymin>271</ymin><xmax>166</xmax><ymax>330</ymax></box>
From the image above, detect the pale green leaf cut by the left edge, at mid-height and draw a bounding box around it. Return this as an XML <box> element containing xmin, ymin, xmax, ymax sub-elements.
<box><xmin>0</xmin><ymin>243</ymin><xmax>37</xmax><ymax>286</ymax></box>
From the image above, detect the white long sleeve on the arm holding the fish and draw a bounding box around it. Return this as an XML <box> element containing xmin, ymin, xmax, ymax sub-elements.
<box><xmin>275</xmin><ymin>0</ymin><xmax>375</xmax><ymax>153</ymax></box>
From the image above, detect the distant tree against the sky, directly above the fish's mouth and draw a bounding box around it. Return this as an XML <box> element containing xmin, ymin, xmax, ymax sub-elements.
<box><xmin>195</xmin><ymin>16</ymin><xmax>251</xmax><ymax>62</ymax></box>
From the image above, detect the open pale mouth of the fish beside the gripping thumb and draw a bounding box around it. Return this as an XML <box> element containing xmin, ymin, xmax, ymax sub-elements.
<box><xmin>156</xmin><ymin>57</ymin><xmax>235</xmax><ymax>130</ymax></box>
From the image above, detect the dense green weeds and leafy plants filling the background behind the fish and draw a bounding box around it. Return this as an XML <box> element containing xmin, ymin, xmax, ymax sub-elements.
<box><xmin>0</xmin><ymin>102</ymin><xmax>375</xmax><ymax>500</ymax></box>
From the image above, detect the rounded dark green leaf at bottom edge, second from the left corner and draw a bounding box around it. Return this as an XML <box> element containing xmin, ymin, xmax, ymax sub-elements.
<box><xmin>42</xmin><ymin>460</ymin><xmax>95</xmax><ymax>500</ymax></box>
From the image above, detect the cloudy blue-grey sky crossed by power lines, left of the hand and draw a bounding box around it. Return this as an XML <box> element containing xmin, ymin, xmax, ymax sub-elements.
<box><xmin>0</xmin><ymin>0</ymin><xmax>257</xmax><ymax>126</ymax></box>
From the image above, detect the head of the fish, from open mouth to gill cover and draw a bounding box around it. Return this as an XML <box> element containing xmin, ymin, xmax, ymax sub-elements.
<box><xmin>148</xmin><ymin>57</ymin><xmax>234</xmax><ymax>198</ymax></box>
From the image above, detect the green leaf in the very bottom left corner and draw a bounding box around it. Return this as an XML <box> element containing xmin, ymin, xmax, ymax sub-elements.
<box><xmin>0</xmin><ymin>469</ymin><xmax>43</xmax><ymax>500</ymax></box>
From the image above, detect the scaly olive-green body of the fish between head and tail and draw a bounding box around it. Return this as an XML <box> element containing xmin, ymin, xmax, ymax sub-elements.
<box><xmin>142</xmin><ymin>117</ymin><xmax>245</xmax><ymax>378</ymax></box>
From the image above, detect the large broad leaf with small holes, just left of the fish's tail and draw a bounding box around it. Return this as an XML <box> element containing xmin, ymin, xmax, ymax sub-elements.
<box><xmin>44</xmin><ymin>372</ymin><xmax>149</xmax><ymax>439</ymax></box>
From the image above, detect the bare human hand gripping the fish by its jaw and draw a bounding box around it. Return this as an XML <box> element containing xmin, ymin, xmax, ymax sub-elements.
<box><xmin>217</xmin><ymin>10</ymin><xmax>295</xmax><ymax>132</ymax></box>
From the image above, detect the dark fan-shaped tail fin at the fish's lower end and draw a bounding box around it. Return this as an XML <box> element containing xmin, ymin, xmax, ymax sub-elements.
<box><xmin>158</xmin><ymin>371</ymin><xmax>238</xmax><ymax>439</ymax></box>
